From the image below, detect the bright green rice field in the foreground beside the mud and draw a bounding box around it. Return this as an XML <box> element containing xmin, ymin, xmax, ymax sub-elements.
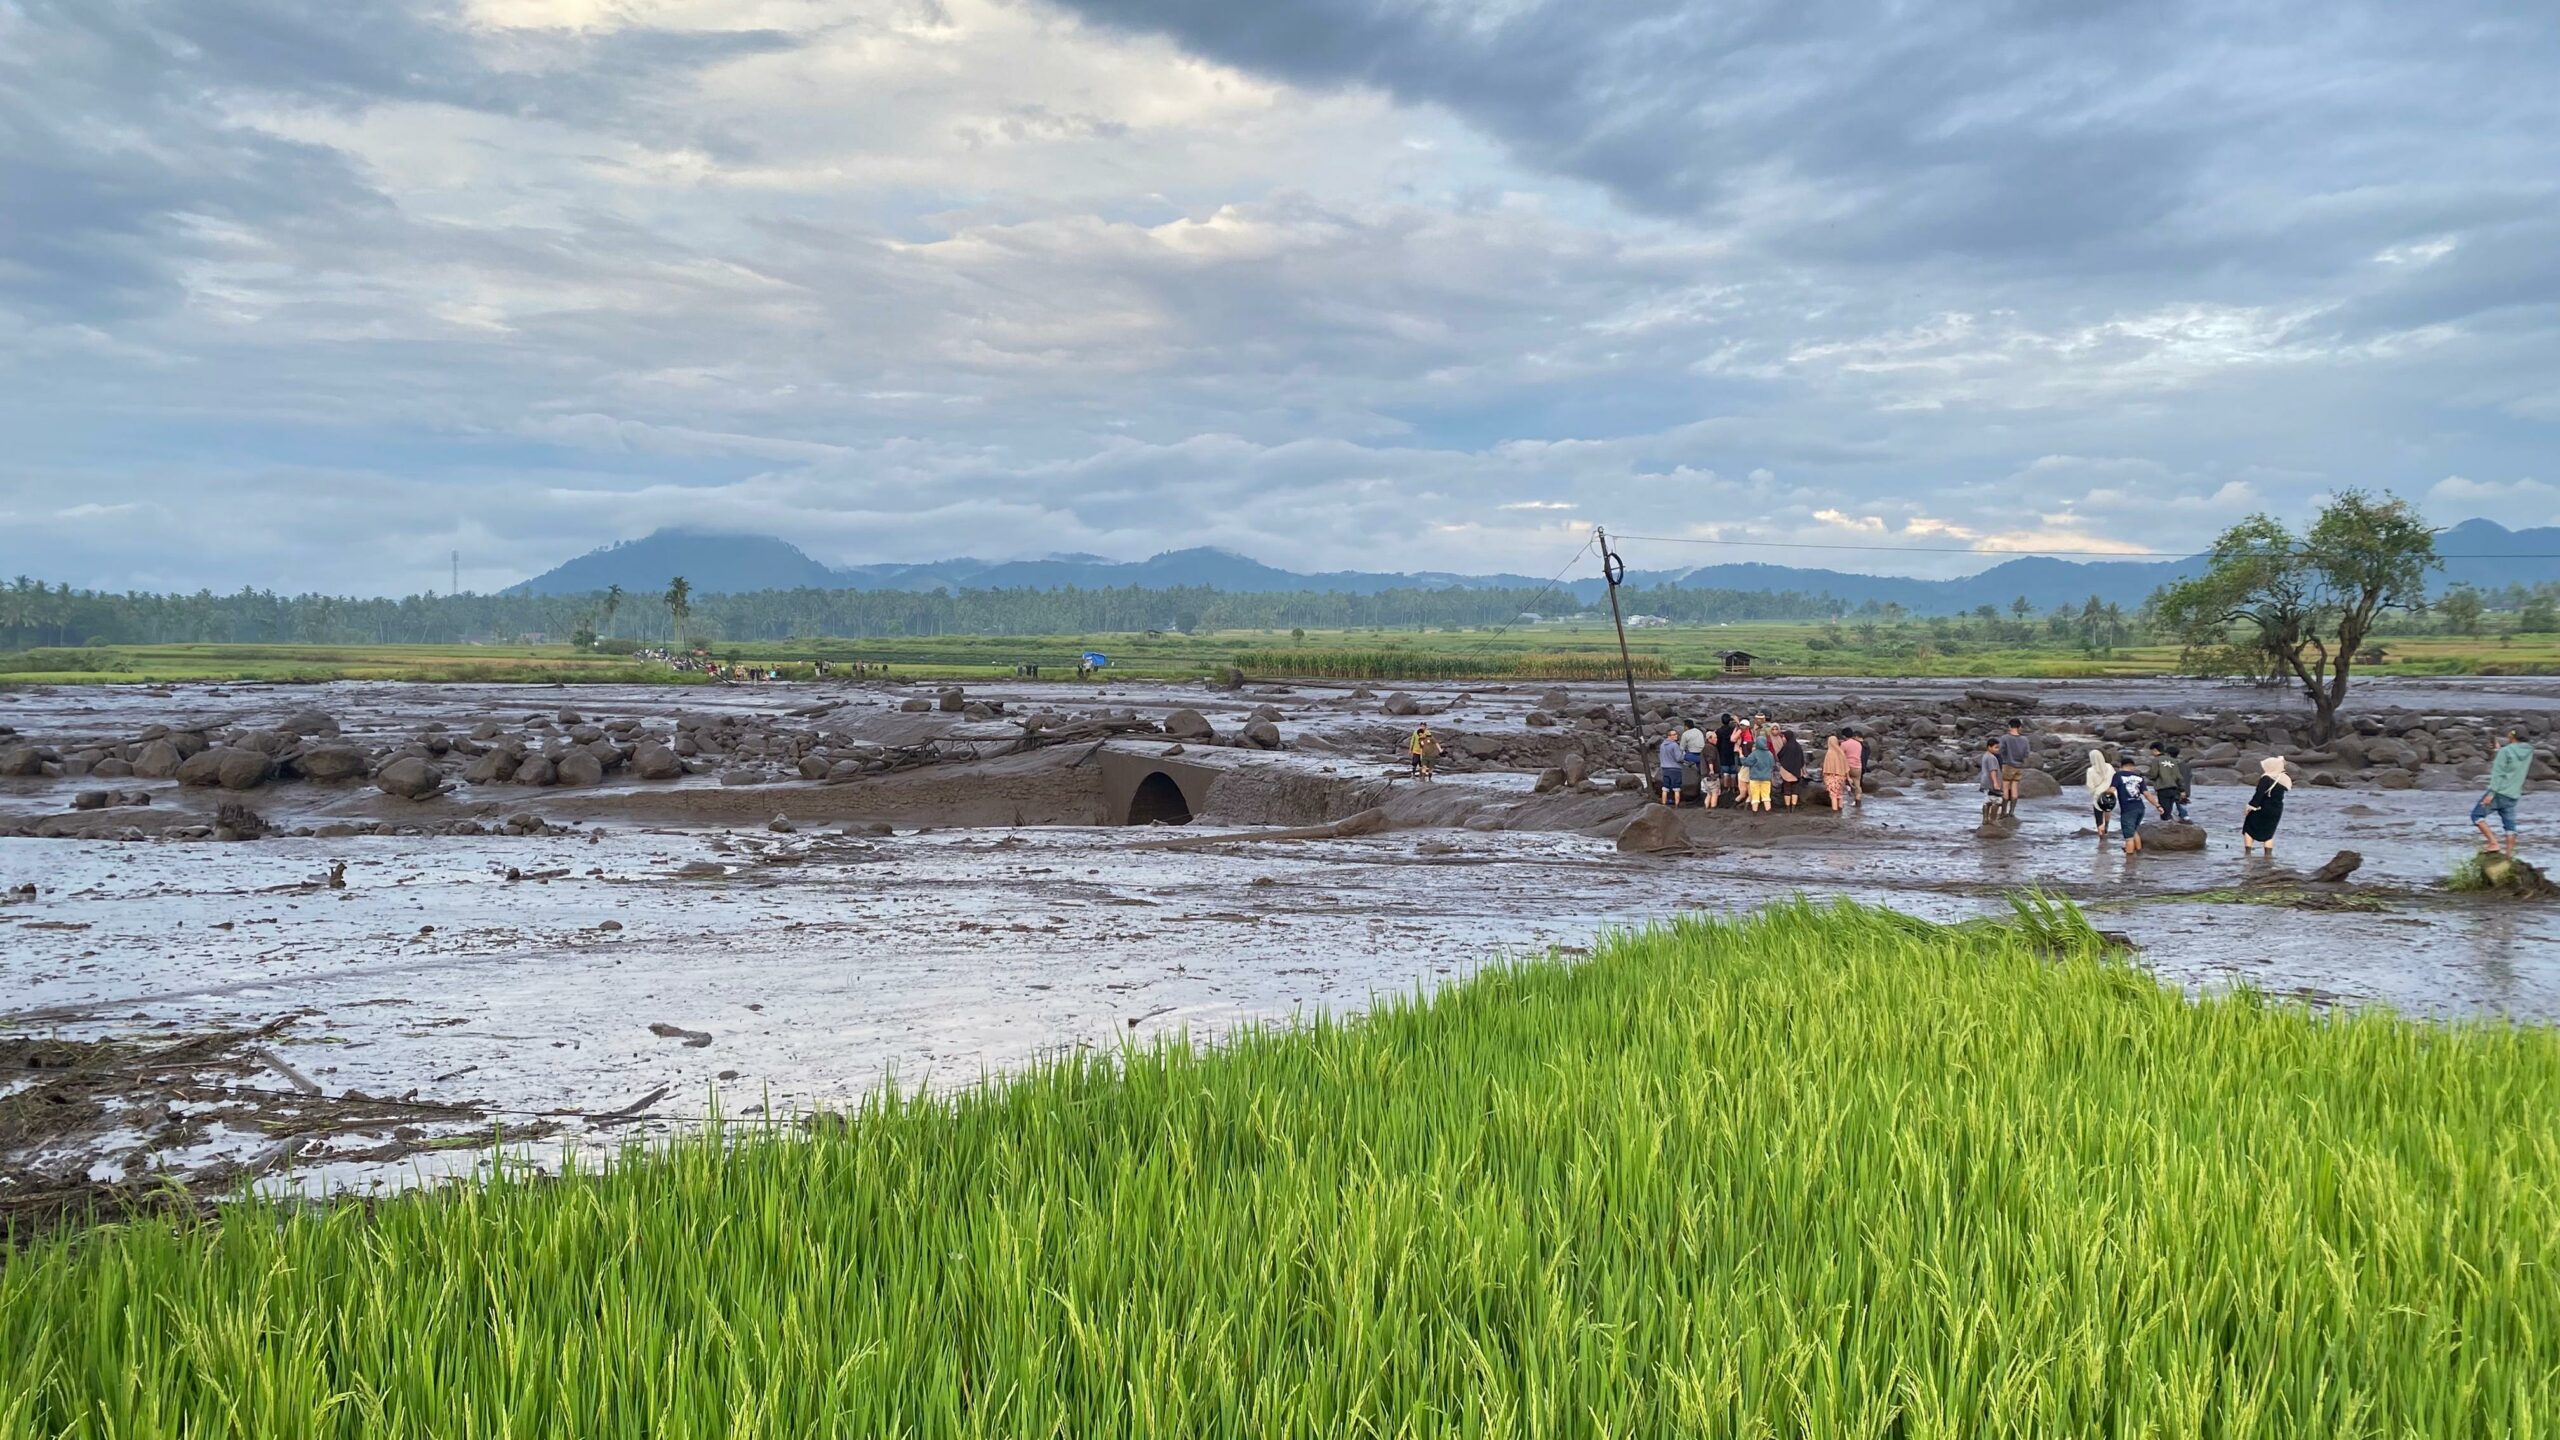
<box><xmin>0</xmin><ymin>904</ymin><xmax>2560</xmax><ymax>1440</ymax></box>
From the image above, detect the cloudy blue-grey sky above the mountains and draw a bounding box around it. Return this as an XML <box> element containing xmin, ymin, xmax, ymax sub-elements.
<box><xmin>0</xmin><ymin>0</ymin><xmax>2560</xmax><ymax>592</ymax></box>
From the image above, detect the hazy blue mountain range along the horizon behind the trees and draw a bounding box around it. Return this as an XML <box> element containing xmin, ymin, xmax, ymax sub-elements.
<box><xmin>509</xmin><ymin>520</ymin><xmax>2560</xmax><ymax>615</ymax></box>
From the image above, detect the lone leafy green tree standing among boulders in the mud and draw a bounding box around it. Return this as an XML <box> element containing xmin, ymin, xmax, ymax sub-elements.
<box><xmin>2153</xmin><ymin>489</ymin><xmax>2437</xmax><ymax>740</ymax></box>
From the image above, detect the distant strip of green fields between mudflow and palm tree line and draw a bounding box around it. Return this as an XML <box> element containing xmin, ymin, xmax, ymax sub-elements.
<box><xmin>0</xmin><ymin>625</ymin><xmax>2560</xmax><ymax>684</ymax></box>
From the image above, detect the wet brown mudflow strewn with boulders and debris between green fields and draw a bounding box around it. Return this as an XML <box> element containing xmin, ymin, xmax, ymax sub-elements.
<box><xmin>0</xmin><ymin>682</ymin><xmax>2560</xmax><ymax>1207</ymax></box>
